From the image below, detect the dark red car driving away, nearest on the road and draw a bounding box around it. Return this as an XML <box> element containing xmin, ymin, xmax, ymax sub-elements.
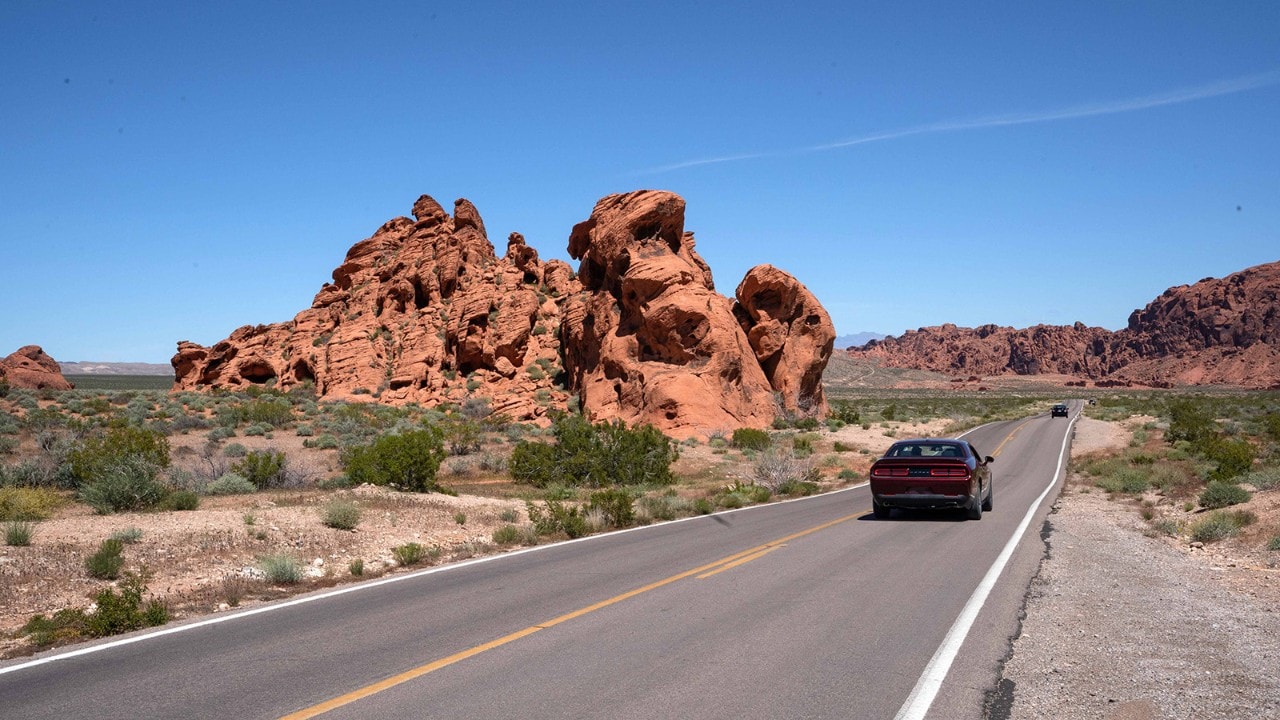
<box><xmin>870</xmin><ymin>438</ymin><xmax>993</xmax><ymax>520</ymax></box>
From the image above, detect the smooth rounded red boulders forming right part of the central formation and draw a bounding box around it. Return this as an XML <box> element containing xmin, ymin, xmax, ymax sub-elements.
<box><xmin>562</xmin><ymin>191</ymin><xmax>835</xmax><ymax>436</ymax></box>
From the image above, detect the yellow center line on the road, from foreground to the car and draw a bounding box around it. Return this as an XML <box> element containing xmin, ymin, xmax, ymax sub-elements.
<box><xmin>280</xmin><ymin>511</ymin><xmax>867</xmax><ymax>720</ymax></box>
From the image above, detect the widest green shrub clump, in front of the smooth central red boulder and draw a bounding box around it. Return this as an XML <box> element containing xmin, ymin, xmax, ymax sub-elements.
<box><xmin>509</xmin><ymin>414</ymin><xmax>677</xmax><ymax>488</ymax></box>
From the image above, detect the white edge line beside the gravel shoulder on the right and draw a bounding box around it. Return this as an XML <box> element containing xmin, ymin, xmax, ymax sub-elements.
<box><xmin>893</xmin><ymin>411</ymin><xmax>1080</xmax><ymax>720</ymax></box>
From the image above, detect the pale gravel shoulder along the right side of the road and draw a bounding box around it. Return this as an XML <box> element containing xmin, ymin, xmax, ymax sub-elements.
<box><xmin>987</xmin><ymin>418</ymin><xmax>1280</xmax><ymax>720</ymax></box>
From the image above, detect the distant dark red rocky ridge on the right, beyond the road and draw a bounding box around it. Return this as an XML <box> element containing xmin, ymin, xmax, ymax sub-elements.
<box><xmin>849</xmin><ymin>263</ymin><xmax>1280</xmax><ymax>388</ymax></box>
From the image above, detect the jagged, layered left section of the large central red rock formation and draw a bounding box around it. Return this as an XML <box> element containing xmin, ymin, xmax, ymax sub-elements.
<box><xmin>172</xmin><ymin>195</ymin><xmax>579</xmax><ymax>420</ymax></box>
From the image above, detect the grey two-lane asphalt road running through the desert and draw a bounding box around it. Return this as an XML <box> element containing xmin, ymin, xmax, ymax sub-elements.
<box><xmin>0</xmin><ymin>406</ymin><xmax>1078</xmax><ymax>720</ymax></box>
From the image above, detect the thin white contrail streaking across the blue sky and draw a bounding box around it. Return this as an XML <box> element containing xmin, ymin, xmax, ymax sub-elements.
<box><xmin>645</xmin><ymin>70</ymin><xmax>1280</xmax><ymax>173</ymax></box>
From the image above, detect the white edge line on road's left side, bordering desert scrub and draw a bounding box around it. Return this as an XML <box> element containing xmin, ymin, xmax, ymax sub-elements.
<box><xmin>0</xmin><ymin>482</ymin><xmax>868</xmax><ymax>675</ymax></box>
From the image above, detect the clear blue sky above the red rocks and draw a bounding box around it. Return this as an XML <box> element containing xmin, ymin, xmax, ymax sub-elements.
<box><xmin>0</xmin><ymin>0</ymin><xmax>1280</xmax><ymax>363</ymax></box>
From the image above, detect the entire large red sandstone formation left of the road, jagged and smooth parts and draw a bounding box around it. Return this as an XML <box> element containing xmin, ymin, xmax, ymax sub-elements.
<box><xmin>172</xmin><ymin>191</ymin><xmax>835</xmax><ymax>437</ymax></box>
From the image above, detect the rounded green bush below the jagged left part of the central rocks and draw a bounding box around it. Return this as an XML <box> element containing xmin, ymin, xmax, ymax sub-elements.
<box><xmin>343</xmin><ymin>427</ymin><xmax>444</xmax><ymax>492</ymax></box>
